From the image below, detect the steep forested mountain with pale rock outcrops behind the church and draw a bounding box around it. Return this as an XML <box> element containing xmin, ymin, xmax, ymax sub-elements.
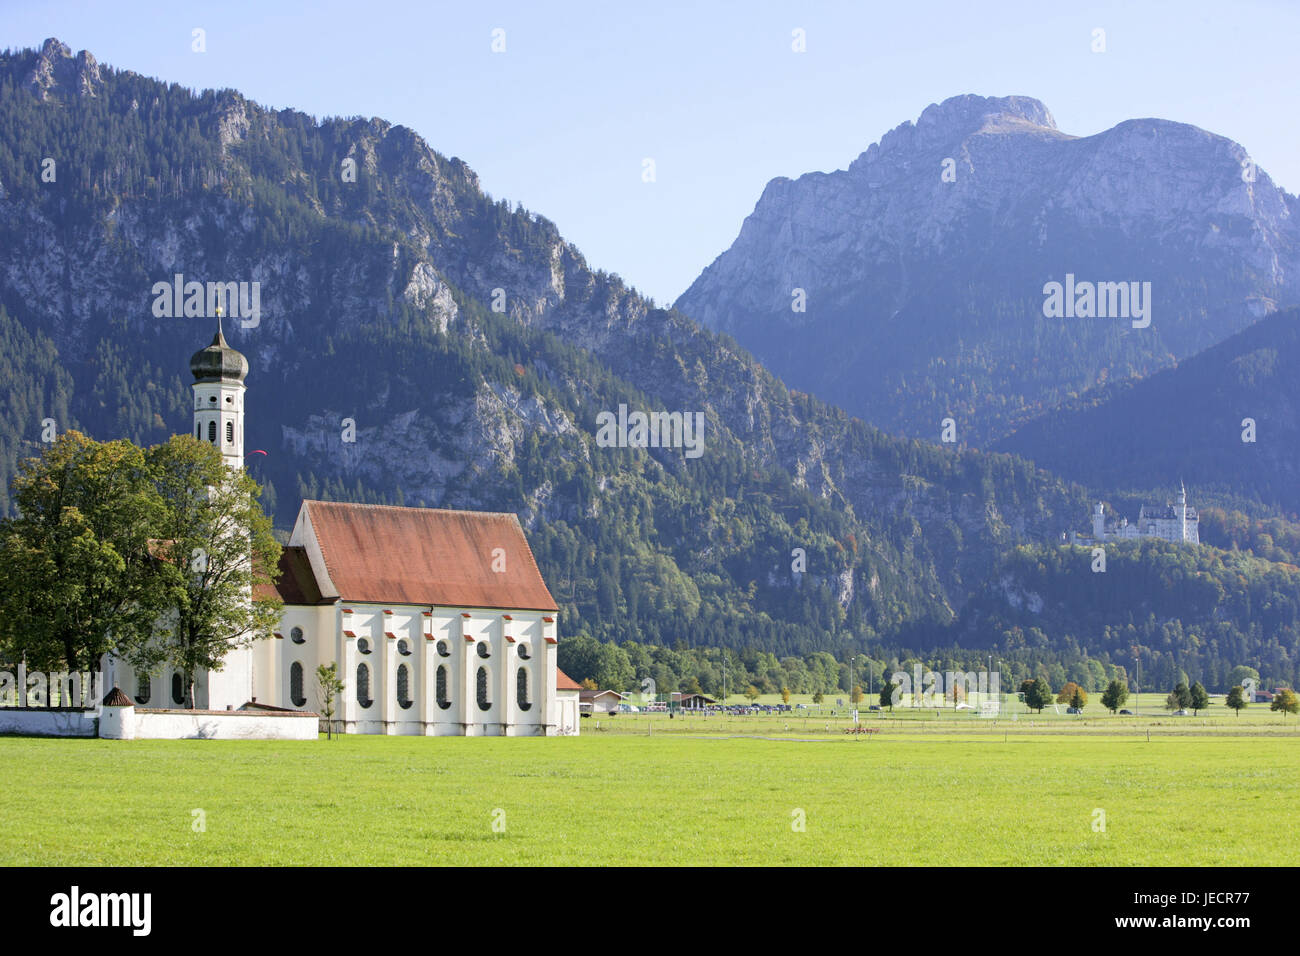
<box><xmin>0</xmin><ymin>40</ymin><xmax>1087</xmax><ymax>650</ymax></box>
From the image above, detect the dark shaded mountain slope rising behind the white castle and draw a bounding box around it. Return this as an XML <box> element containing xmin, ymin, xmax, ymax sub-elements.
<box><xmin>997</xmin><ymin>310</ymin><xmax>1300</xmax><ymax>512</ymax></box>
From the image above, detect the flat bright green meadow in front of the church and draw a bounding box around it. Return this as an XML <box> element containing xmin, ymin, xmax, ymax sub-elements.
<box><xmin>0</xmin><ymin>711</ymin><xmax>1300</xmax><ymax>866</ymax></box>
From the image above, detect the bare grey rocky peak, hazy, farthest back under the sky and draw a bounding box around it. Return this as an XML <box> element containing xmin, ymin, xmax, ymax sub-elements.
<box><xmin>675</xmin><ymin>96</ymin><xmax>1300</xmax><ymax>444</ymax></box>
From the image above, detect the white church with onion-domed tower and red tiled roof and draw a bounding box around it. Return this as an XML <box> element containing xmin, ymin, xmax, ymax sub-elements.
<box><xmin>111</xmin><ymin>328</ymin><xmax>579</xmax><ymax>736</ymax></box>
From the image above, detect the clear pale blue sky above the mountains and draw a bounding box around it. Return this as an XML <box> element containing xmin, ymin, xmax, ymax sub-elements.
<box><xmin>10</xmin><ymin>0</ymin><xmax>1300</xmax><ymax>304</ymax></box>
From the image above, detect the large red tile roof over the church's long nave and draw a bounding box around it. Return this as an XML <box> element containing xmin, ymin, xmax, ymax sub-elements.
<box><xmin>303</xmin><ymin>501</ymin><xmax>559</xmax><ymax>611</ymax></box>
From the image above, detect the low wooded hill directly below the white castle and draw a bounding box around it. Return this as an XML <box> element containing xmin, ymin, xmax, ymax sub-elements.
<box><xmin>950</xmin><ymin>540</ymin><xmax>1300</xmax><ymax>691</ymax></box>
